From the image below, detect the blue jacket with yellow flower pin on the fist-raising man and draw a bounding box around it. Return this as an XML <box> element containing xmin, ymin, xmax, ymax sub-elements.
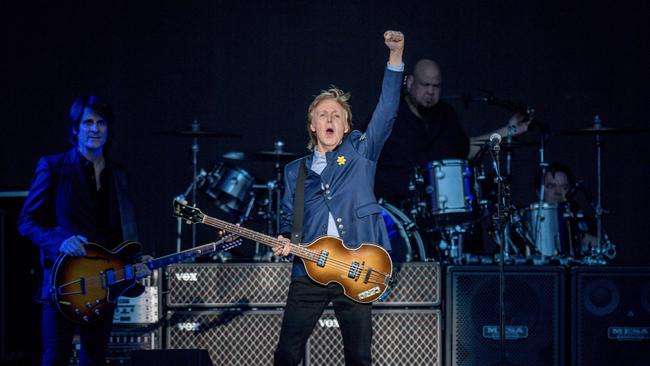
<box><xmin>280</xmin><ymin>69</ymin><xmax>402</xmax><ymax>276</ymax></box>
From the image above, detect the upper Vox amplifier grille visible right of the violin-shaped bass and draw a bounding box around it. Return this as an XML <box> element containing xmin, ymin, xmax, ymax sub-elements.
<box><xmin>373</xmin><ymin>262</ymin><xmax>441</xmax><ymax>307</ymax></box>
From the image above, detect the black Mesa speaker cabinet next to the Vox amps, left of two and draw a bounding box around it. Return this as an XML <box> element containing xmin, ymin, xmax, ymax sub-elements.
<box><xmin>445</xmin><ymin>266</ymin><xmax>565</xmax><ymax>366</ymax></box>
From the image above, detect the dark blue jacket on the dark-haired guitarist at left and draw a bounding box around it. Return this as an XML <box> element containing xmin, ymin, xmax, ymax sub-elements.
<box><xmin>18</xmin><ymin>148</ymin><xmax>137</xmax><ymax>299</ymax></box>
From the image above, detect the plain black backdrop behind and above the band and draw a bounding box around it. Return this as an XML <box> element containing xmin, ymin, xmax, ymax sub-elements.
<box><xmin>0</xmin><ymin>0</ymin><xmax>650</xmax><ymax>263</ymax></box>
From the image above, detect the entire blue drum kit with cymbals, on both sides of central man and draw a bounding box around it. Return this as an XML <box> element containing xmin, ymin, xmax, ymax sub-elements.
<box><xmin>164</xmin><ymin>116</ymin><xmax>638</xmax><ymax>264</ymax></box>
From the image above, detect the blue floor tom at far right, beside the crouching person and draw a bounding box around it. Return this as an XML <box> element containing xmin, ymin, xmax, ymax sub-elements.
<box><xmin>524</xmin><ymin>202</ymin><xmax>569</xmax><ymax>257</ymax></box>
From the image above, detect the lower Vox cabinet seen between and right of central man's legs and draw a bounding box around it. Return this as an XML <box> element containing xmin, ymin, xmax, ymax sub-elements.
<box><xmin>306</xmin><ymin>309</ymin><xmax>441</xmax><ymax>366</ymax></box>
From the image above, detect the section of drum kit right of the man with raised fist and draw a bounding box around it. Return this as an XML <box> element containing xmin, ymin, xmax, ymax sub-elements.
<box><xmin>380</xmin><ymin>116</ymin><xmax>648</xmax><ymax>265</ymax></box>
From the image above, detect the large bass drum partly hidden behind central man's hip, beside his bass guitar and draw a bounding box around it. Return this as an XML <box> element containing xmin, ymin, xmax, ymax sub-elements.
<box><xmin>379</xmin><ymin>200</ymin><xmax>427</xmax><ymax>262</ymax></box>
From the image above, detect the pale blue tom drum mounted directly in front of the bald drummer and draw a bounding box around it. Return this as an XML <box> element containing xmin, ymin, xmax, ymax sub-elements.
<box><xmin>422</xmin><ymin>160</ymin><xmax>474</xmax><ymax>226</ymax></box>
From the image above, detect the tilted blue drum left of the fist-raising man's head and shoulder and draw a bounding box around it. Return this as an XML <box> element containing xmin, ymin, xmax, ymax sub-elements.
<box><xmin>199</xmin><ymin>163</ymin><xmax>255</xmax><ymax>214</ymax></box>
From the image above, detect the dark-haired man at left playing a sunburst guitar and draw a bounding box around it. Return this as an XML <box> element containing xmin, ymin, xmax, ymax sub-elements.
<box><xmin>18</xmin><ymin>96</ymin><xmax>150</xmax><ymax>365</ymax></box>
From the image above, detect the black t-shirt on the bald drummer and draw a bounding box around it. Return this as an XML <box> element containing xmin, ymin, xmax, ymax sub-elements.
<box><xmin>375</xmin><ymin>98</ymin><xmax>469</xmax><ymax>203</ymax></box>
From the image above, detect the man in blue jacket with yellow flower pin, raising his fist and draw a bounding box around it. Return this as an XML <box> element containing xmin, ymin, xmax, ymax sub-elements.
<box><xmin>274</xmin><ymin>31</ymin><xmax>404</xmax><ymax>365</ymax></box>
